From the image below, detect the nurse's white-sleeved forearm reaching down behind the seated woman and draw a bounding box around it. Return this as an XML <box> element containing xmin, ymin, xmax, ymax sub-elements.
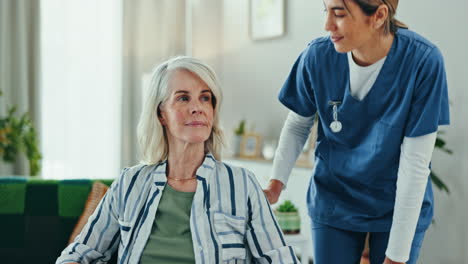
<box><xmin>271</xmin><ymin>112</ymin><xmax>314</xmax><ymax>189</ymax></box>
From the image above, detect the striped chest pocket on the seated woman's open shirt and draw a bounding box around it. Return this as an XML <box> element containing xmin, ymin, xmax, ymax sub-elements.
<box><xmin>213</xmin><ymin>212</ymin><xmax>246</xmax><ymax>262</ymax></box>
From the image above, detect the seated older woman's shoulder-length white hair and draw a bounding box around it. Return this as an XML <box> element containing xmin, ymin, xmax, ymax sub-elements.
<box><xmin>137</xmin><ymin>56</ymin><xmax>223</xmax><ymax>164</ymax></box>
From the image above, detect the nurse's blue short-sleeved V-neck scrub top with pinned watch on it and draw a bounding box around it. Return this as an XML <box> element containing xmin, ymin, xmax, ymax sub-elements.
<box><xmin>279</xmin><ymin>29</ymin><xmax>450</xmax><ymax>232</ymax></box>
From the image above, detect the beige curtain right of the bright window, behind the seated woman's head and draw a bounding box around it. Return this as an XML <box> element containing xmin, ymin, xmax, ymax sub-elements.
<box><xmin>121</xmin><ymin>0</ymin><xmax>186</xmax><ymax>166</ymax></box>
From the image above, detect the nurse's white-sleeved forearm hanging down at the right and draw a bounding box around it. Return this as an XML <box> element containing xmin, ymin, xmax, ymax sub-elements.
<box><xmin>385</xmin><ymin>132</ymin><xmax>437</xmax><ymax>262</ymax></box>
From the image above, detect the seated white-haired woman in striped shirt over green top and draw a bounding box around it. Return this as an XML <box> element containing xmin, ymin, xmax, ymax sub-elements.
<box><xmin>56</xmin><ymin>57</ymin><xmax>298</xmax><ymax>264</ymax></box>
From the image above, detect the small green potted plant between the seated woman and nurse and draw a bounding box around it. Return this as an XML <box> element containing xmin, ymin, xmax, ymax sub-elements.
<box><xmin>275</xmin><ymin>200</ymin><xmax>301</xmax><ymax>234</ymax></box>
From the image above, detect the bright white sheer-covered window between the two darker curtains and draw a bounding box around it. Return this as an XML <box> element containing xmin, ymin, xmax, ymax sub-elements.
<box><xmin>39</xmin><ymin>0</ymin><xmax>122</xmax><ymax>178</ymax></box>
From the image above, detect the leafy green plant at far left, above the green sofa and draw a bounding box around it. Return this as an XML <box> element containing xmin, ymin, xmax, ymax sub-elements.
<box><xmin>0</xmin><ymin>91</ymin><xmax>42</xmax><ymax>176</ymax></box>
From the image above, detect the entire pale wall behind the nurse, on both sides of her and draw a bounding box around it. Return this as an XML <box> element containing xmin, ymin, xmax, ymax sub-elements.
<box><xmin>198</xmin><ymin>0</ymin><xmax>468</xmax><ymax>264</ymax></box>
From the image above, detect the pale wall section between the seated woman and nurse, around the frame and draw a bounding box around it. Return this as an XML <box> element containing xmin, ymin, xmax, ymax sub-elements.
<box><xmin>220</xmin><ymin>0</ymin><xmax>323</xmax><ymax>143</ymax></box>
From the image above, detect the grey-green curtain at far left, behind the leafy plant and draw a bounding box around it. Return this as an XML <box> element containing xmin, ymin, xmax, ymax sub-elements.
<box><xmin>0</xmin><ymin>0</ymin><xmax>40</xmax><ymax>175</ymax></box>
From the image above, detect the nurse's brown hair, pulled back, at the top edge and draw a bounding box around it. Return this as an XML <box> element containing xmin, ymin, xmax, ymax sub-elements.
<box><xmin>343</xmin><ymin>0</ymin><xmax>408</xmax><ymax>34</ymax></box>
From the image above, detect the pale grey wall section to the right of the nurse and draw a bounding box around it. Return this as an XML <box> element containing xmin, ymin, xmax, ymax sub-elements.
<box><xmin>399</xmin><ymin>0</ymin><xmax>468</xmax><ymax>263</ymax></box>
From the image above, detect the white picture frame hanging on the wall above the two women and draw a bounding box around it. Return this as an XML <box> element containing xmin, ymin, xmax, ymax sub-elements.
<box><xmin>249</xmin><ymin>0</ymin><xmax>286</xmax><ymax>40</ymax></box>
